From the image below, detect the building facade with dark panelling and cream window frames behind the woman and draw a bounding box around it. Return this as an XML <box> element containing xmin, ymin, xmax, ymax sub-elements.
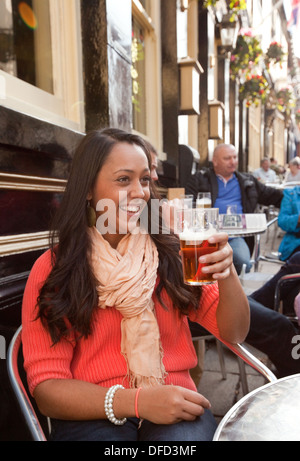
<box><xmin>0</xmin><ymin>0</ymin><xmax>299</xmax><ymax>440</ymax></box>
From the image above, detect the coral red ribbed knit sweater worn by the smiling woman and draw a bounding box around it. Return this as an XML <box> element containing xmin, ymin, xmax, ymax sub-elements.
<box><xmin>22</xmin><ymin>250</ymin><xmax>220</xmax><ymax>393</ymax></box>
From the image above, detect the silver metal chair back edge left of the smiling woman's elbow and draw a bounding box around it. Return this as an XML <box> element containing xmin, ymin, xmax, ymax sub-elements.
<box><xmin>7</xmin><ymin>327</ymin><xmax>47</xmax><ymax>442</ymax></box>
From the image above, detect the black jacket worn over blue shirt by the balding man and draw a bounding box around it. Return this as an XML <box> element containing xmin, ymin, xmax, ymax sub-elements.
<box><xmin>185</xmin><ymin>168</ymin><xmax>283</xmax><ymax>253</ymax></box>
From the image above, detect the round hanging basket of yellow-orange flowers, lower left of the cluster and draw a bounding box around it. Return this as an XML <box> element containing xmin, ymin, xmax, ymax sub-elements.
<box><xmin>240</xmin><ymin>75</ymin><xmax>269</xmax><ymax>107</ymax></box>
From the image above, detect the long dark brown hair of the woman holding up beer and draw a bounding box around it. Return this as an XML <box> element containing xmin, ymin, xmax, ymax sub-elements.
<box><xmin>38</xmin><ymin>129</ymin><xmax>200</xmax><ymax>343</ymax></box>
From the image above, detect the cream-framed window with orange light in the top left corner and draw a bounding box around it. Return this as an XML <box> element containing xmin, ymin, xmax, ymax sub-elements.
<box><xmin>0</xmin><ymin>0</ymin><xmax>84</xmax><ymax>131</ymax></box>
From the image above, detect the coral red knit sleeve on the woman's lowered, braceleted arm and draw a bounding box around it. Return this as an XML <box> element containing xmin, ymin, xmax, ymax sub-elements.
<box><xmin>22</xmin><ymin>250</ymin><xmax>73</xmax><ymax>394</ymax></box>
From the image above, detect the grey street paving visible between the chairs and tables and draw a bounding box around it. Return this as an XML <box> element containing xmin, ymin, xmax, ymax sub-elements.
<box><xmin>198</xmin><ymin>217</ymin><xmax>283</xmax><ymax>422</ymax></box>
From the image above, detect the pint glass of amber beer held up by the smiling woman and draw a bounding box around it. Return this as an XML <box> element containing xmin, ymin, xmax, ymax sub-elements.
<box><xmin>179</xmin><ymin>208</ymin><xmax>219</xmax><ymax>285</ymax></box>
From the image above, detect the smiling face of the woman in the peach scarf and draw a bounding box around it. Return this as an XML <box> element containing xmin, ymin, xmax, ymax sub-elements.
<box><xmin>88</xmin><ymin>142</ymin><xmax>150</xmax><ymax>248</ymax></box>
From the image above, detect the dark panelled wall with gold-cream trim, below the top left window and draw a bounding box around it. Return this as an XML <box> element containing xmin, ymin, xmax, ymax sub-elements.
<box><xmin>0</xmin><ymin>107</ymin><xmax>82</xmax><ymax>440</ymax></box>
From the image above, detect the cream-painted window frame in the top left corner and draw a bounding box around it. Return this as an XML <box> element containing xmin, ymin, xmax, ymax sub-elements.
<box><xmin>0</xmin><ymin>0</ymin><xmax>84</xmax><ymax>132</ymax></box>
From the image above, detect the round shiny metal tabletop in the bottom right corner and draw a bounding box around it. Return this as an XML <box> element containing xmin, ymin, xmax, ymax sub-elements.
<box><xmin>214</xmin><ymin>374</ymin><xmax>300</xmax><ymax>441</ymax></box>
